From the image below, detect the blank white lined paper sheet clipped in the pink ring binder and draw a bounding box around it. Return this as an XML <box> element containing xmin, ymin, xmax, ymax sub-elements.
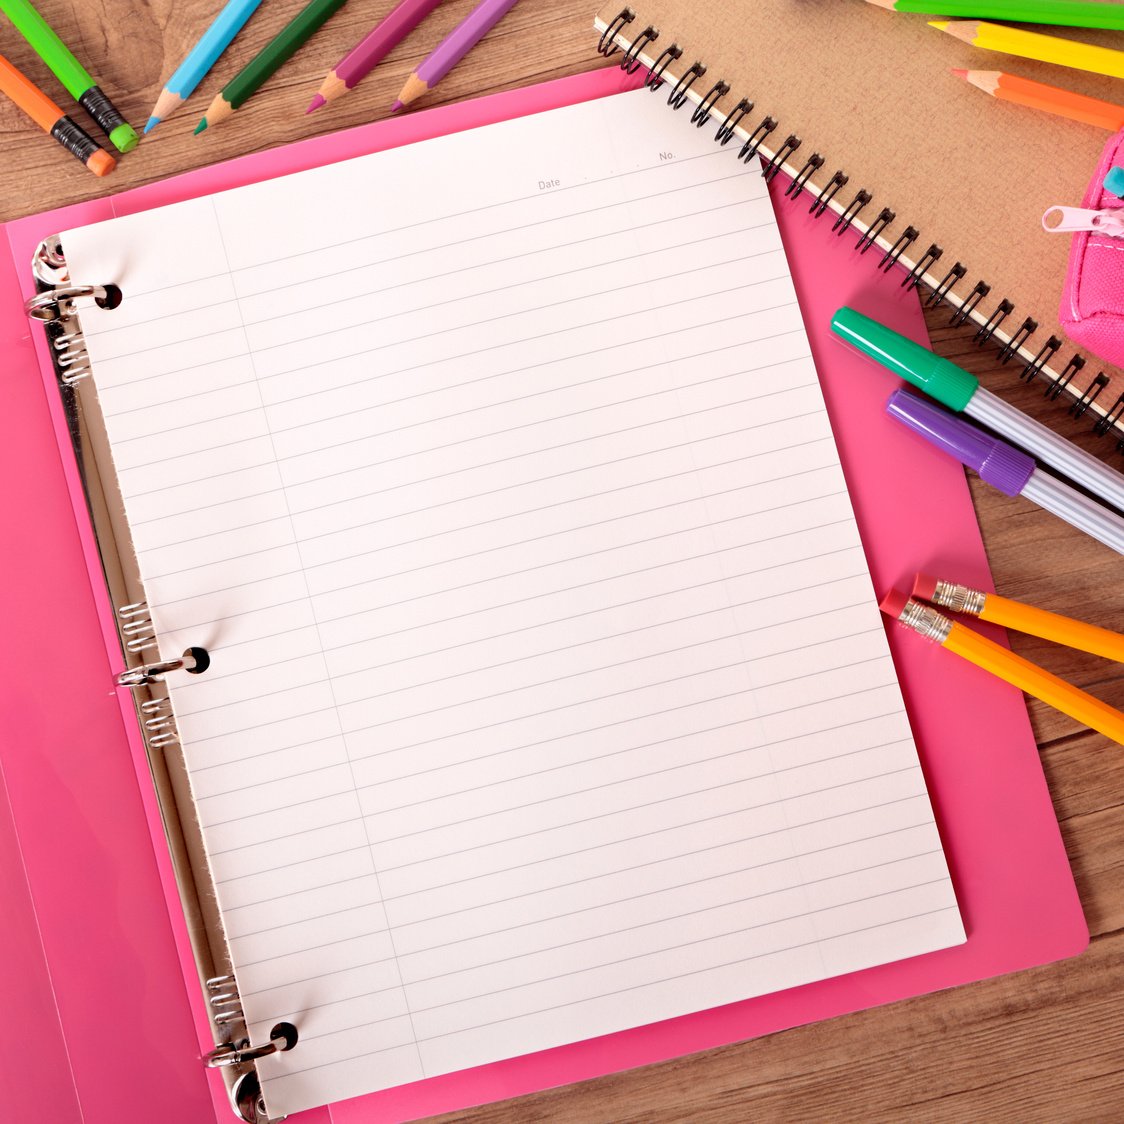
<box><xmin>63</xmin><ymin>91</ymin><xmax>964</xmax><ymax>1115</ymax></box>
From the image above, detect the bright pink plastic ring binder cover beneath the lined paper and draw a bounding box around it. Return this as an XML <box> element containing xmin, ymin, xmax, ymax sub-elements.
<box><xmin>0</xmin><ymin>67</ymin><xmax>1088</xmax><ymax>1124</ymax></box>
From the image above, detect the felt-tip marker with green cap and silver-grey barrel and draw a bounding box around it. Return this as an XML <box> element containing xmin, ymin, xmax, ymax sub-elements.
<box><xmin>832</xmin><ymin>308</ymin><xmax>1124</xmax><ymax>511</ymax></box>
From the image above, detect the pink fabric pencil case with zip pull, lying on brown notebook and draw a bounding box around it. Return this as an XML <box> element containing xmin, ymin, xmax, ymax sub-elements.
<box><xmin>1042</xmin><ymin>130</ymin><xmax>1124</xmax><ymax>366</ymax></box>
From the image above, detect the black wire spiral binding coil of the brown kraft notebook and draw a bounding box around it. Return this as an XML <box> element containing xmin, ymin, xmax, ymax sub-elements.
<box><xmin>597</xmin><ymin>8</ymin><xmax>1124</xmax><ymax>453</ymax></box>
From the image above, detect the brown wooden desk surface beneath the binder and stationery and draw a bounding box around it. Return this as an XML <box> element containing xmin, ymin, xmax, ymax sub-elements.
<box><xmin>0</xmin><ymin>0</ymin><xmax>1124</xmax><ymax>1124</ymax></box>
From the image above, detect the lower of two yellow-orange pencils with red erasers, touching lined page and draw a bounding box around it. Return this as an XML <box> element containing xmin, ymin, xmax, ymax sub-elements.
<box><xmin>881</xmin><ymin>589</ymin><xmax>1124</xmax><ymax>745</ymax></box>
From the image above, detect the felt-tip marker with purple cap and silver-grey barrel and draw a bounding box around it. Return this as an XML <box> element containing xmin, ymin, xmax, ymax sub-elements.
<box><xmin>886</xmin><ymin>390</ymin><xmax>1124</xmax><ymax>554</ymax></box>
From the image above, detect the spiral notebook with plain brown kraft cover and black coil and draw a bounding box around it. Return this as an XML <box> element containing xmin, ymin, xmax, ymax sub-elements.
<box><xmin>596</xmin><ymin>0</ymin><xmax>1124</xmax><ymax>448</ymax></box>
